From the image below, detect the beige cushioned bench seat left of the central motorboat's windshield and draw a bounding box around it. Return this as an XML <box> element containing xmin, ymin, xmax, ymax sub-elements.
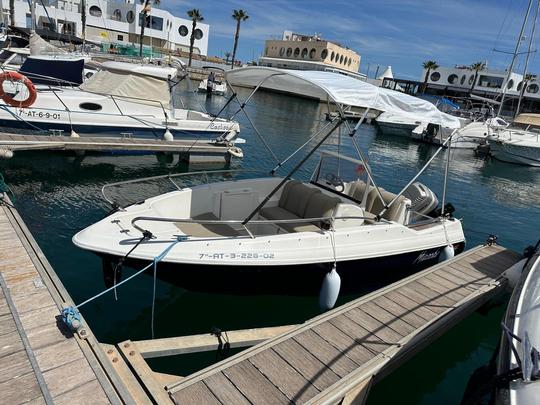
<box><xmin>260</xmin><ymin>181</ymin><xmax>341</xmax><ymax>232</ymax></box>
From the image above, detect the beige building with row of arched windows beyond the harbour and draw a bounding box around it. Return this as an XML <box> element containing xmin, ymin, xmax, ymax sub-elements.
<box><xmin>259</xmin><ymin>31</ymin><xmax>364</xmax><ymax>76</ymax></box>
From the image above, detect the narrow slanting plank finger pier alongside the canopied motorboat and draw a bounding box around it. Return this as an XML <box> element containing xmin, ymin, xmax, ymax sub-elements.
<box><xmin>167</xmin><ymin>241</ymin><xmax>520</xmax><ymax>404</ymax></box>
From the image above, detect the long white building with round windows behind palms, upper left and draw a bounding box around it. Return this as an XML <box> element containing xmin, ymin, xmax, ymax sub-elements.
<box><xmin>2</xmin><ymin>0</ymin><xmax>210</xmax><ymax>55</ymax></box>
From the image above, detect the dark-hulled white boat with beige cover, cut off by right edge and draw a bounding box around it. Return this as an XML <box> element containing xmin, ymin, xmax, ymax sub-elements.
<box><xmin>488</xmin><ymin>114</ymin><xmax>540</xmax><ymax>166</ymax></box>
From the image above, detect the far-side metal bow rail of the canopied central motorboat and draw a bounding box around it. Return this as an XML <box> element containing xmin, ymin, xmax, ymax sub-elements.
<box><xmin>101</xmin><ymin>169</ymin><xmax>273</xmax><ymax>211</ymax></box>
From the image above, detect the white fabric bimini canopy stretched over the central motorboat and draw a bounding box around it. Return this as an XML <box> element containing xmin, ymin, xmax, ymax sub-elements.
<box><xmin>225</xmin><ymin>67</ymin><xmax>460</xmax><ymax>128</ymax></box>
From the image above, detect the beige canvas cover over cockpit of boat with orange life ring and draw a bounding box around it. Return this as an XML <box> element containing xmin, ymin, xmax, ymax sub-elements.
<box><xmin>79</xmin><ymin>70</ymin><xmax>171</xmax><ymax>108</ymax></box>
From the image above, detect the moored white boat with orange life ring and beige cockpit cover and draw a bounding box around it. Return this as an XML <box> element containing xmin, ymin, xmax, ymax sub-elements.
<box><xmin>0</xmin><ymin>62</ymin><xmax>239</xmax><ymax>141</ymax></box>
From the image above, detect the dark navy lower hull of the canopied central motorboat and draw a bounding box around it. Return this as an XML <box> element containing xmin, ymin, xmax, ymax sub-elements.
<box><xmin>98</xmin><ymin>242</ymin><xmax>465</xmax><ymax>295</ymax></box>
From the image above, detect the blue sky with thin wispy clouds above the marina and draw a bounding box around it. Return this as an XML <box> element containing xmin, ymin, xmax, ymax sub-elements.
<box><xmin>160</xmin><ymin>0</ymin><xmax>540</xmax><ymax>80</ymax></box>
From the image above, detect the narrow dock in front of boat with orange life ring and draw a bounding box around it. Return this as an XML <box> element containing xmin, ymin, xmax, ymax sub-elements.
<box><xmin>0</xmin><ymin>133</ymin><xmax>231</xmax><ymax>163</ymax></box>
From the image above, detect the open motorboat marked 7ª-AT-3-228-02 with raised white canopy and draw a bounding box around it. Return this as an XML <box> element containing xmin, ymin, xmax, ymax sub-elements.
<box><xmin>73</xmin><ymin>68</ymin><xmax>465</xmax><ymax>291</ymax></box>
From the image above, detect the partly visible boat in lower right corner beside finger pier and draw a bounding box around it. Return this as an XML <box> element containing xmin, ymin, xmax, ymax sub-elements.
<box><xmin>497</xmin><ymin>245</ymin><xmax>540</xmax><ymax>405</ymax></box>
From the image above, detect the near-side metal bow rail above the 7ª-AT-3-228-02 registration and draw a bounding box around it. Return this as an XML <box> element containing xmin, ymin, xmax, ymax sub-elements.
<box><xmin>131</xmin><ymin>215</ymin><xmax>392</xmax><ymax>239</ymax></box>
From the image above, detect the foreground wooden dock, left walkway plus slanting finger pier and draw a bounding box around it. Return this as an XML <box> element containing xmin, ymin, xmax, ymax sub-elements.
<box><xmin>0</xmin><ymin>188</ymin><xmax>520</xmax><ymax>404</ymax></box>
